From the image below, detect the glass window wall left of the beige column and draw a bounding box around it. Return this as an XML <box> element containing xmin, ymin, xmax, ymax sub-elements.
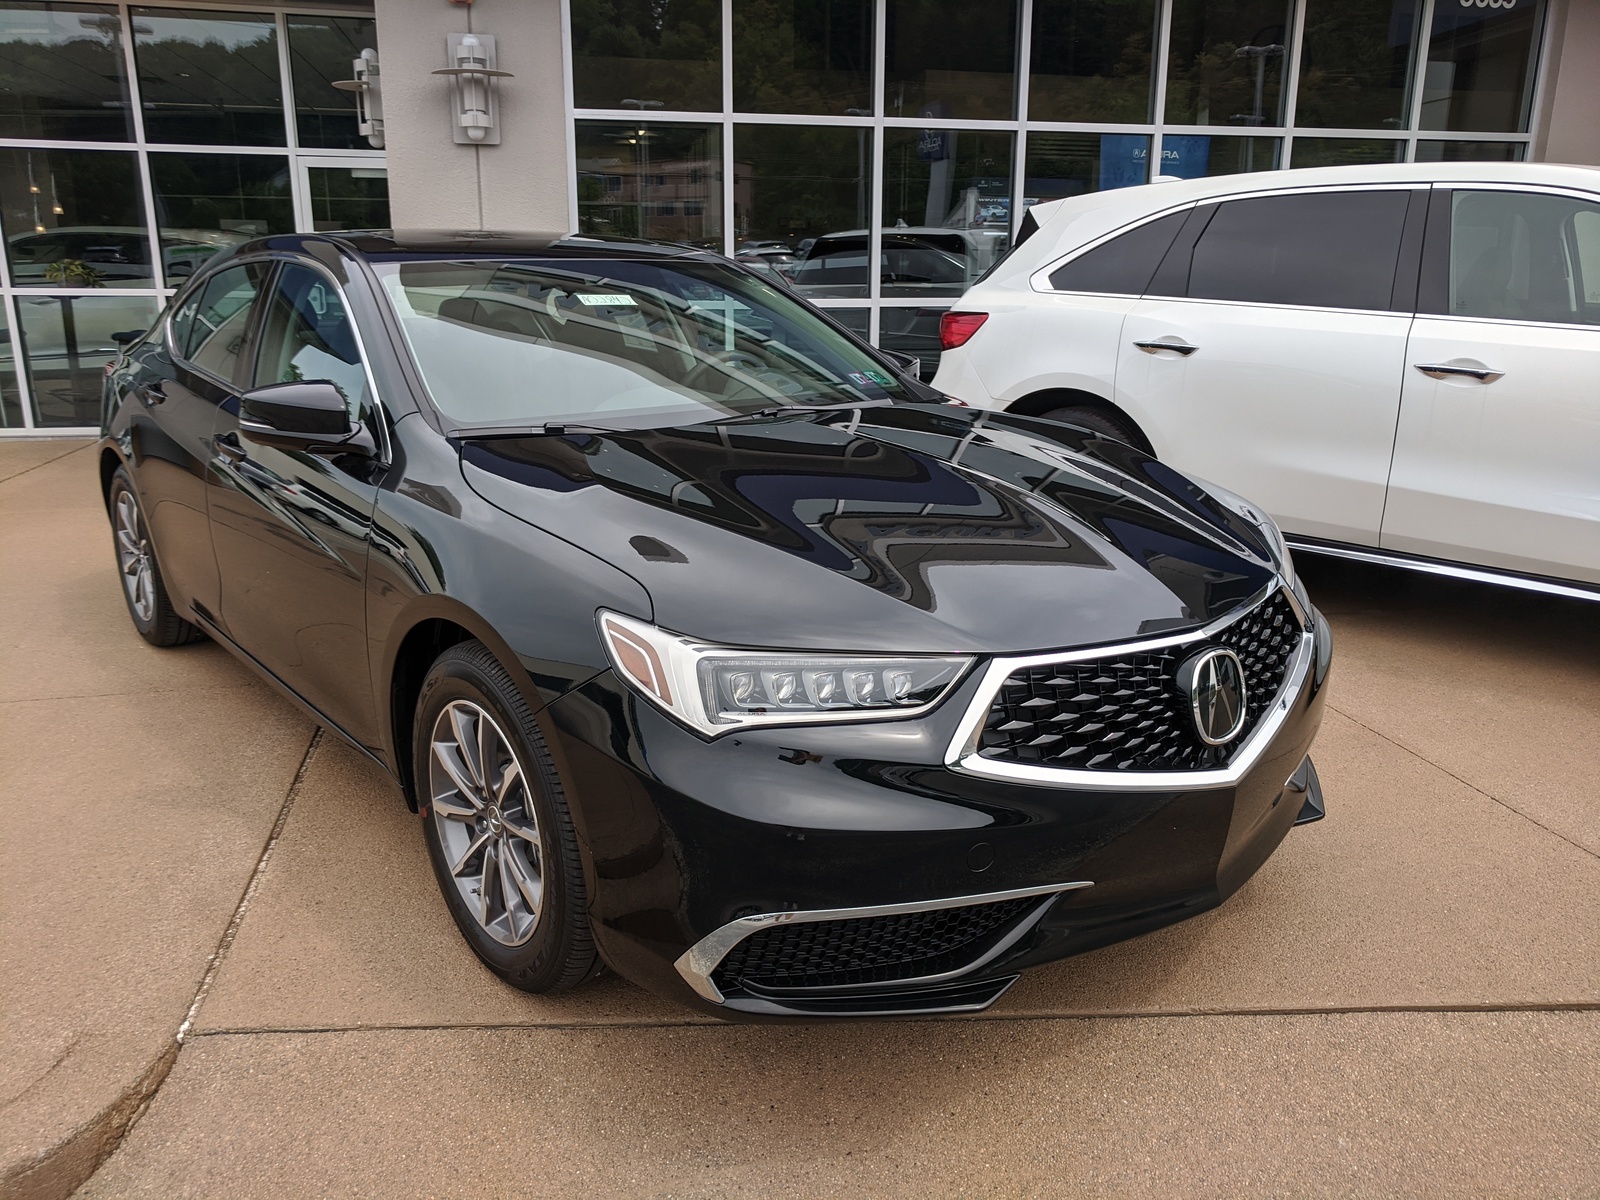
<box><xmin>0</xmin><ymin>0</ymin><xmax>385</xmax><ymax>430</ymax></box>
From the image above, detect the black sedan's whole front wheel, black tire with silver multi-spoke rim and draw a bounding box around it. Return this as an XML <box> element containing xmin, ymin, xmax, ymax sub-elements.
<box><xmin>411</xmin><ymin>642</ymin><xmax>600</xmax><ymax>992</ymax></box>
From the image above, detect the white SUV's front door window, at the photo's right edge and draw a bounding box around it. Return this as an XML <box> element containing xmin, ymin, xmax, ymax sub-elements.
<box><xmin>1450</xmin><ymin>192</ymin><xmax>1600</xmax><ymax>325</ymax></box>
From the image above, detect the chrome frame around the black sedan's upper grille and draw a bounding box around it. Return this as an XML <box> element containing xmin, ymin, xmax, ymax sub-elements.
<box><xmin>944</xmin><ymin>578</ymin><xmax>1317</xmax><ymax>792</ymax></box>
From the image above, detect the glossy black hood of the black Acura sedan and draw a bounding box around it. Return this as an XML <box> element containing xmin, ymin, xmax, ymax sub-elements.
<box><xmin>461</xmin><ymin>405</ymin><xmax>1274</xmax><ymax>651</ymax></box>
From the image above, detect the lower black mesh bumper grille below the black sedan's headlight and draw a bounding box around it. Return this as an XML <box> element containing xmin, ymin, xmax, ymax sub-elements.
<box><xmin>712</xmin><ymin>896</ymin><xmax>1045</xmax><ymax>994</ymax></box>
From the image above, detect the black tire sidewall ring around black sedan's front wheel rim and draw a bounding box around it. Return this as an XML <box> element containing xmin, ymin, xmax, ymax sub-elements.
<box><xmin>411</xmin><ymin>653</ymin><xmax>573</xmax><ymax>992</ymax></box>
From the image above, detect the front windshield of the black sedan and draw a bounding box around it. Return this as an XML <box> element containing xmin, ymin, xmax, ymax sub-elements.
<box><xmin>374</xmin><ymin>259</ymin><xmax>910</xmax><ymax>427</ymax></box>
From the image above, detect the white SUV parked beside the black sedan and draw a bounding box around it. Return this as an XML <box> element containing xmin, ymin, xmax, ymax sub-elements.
<box><xmin>933</xmin><ymin>163</ymin><xmax>1600</xmax><ymax>598</ymax></box>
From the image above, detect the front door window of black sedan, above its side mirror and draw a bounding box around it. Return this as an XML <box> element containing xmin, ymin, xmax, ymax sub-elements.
<box><xmin>256</xmin><ymin>264</ymin><xmax>366</xmax><ymax>418</ymax></box>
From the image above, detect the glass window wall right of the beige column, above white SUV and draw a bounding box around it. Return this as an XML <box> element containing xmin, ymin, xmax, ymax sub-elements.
<box><xmin>566</xmin><ymin>0</ymin><xmax>1546</xmax><ymax>374</ymax></box>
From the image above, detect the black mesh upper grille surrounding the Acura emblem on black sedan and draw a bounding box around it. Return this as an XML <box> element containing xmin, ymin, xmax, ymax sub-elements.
<box><xmin>978</xmin><ymin>590</ymin><xmax>1302</xmax><ymax>771</ymax></box>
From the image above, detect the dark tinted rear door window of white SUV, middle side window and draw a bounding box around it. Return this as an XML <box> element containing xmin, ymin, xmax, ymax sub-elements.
<box><xmin>1189</xmin><ymin>190</ymin><xmax>1410</xmax><ymax>310</ymax></box>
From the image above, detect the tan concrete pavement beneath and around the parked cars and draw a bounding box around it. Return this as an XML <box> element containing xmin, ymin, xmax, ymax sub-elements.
<box><xmin>0</xmin><ymin>443</ymin><xmax>1600</xmax><ymax>1195</ymax></box>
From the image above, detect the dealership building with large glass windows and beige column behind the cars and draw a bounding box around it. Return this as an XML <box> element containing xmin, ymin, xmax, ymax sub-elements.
<box><xmin>0</xmin><ymin>0</ymin><xmax>1600</xmax><ymax>435</ymax></box>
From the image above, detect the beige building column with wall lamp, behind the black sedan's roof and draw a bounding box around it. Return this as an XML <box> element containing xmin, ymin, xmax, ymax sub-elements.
<box><xmin>376</xmin><ymin>0</ymin><xmax>574</xmax><ymax>234</ymax></box>
